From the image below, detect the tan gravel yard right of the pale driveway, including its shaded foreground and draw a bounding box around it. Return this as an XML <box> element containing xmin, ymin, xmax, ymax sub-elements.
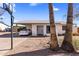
<box><xmin>5</xmin><ymin>37</ymin><xmax>79</xmax><ymax>56</ymax></box>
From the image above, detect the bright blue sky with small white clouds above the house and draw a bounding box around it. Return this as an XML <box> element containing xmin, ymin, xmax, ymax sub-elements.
<box><xmin>0</xmin><ymin>3</ymin><xmax>78</xmax><ymax>24</ymax></box>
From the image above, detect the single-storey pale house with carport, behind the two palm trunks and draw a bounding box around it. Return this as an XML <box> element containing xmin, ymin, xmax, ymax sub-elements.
<box><xmin>13</xmin><ymin>20</ymin><xmax>77</xmax><ymax>36</ymax></box>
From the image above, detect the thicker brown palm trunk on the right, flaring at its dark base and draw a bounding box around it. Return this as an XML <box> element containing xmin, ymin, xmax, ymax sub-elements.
<box><xmin>61</xmin><ymin>3</ymin><xmax>74</xmax><ymax>52</ymax></box>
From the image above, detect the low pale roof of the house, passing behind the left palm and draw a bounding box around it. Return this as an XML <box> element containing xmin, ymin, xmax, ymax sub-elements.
<box><xmin>14</xmin><ymin>20</ymin><xmax>65</xmax><ymax>24</ymax></box>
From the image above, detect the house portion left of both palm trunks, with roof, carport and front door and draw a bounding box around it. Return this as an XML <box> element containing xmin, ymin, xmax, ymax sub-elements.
<box><xmin>13</xmin><ymin>20</ymin><xmax>50</xmax><ymax>36</ymax></box>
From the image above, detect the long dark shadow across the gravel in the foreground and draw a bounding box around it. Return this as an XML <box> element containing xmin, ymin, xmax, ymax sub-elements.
<box><xmin>7</xmin><ymin>48</ymin><xmax>79</xmax><ymax>56</ymax></box>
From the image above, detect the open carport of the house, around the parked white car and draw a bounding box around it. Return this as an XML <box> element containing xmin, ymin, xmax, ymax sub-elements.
<box><xmin>13</xmin><ymin>23</ymin><xmax>32</xmax><ymax>36</ymax></box>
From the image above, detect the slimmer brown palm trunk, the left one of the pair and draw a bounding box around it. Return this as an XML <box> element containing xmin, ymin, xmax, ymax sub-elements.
<box><xmin>48</xmin><ymin>3</ymin><xmax>58</xmax><ymax>50</ymax></box>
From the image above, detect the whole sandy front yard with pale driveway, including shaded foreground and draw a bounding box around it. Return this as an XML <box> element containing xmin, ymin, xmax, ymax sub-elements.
<box><xmin>0</xmin><ymin>33</ymin><xmax>79</xmax><ymax>56</ymax></box>
